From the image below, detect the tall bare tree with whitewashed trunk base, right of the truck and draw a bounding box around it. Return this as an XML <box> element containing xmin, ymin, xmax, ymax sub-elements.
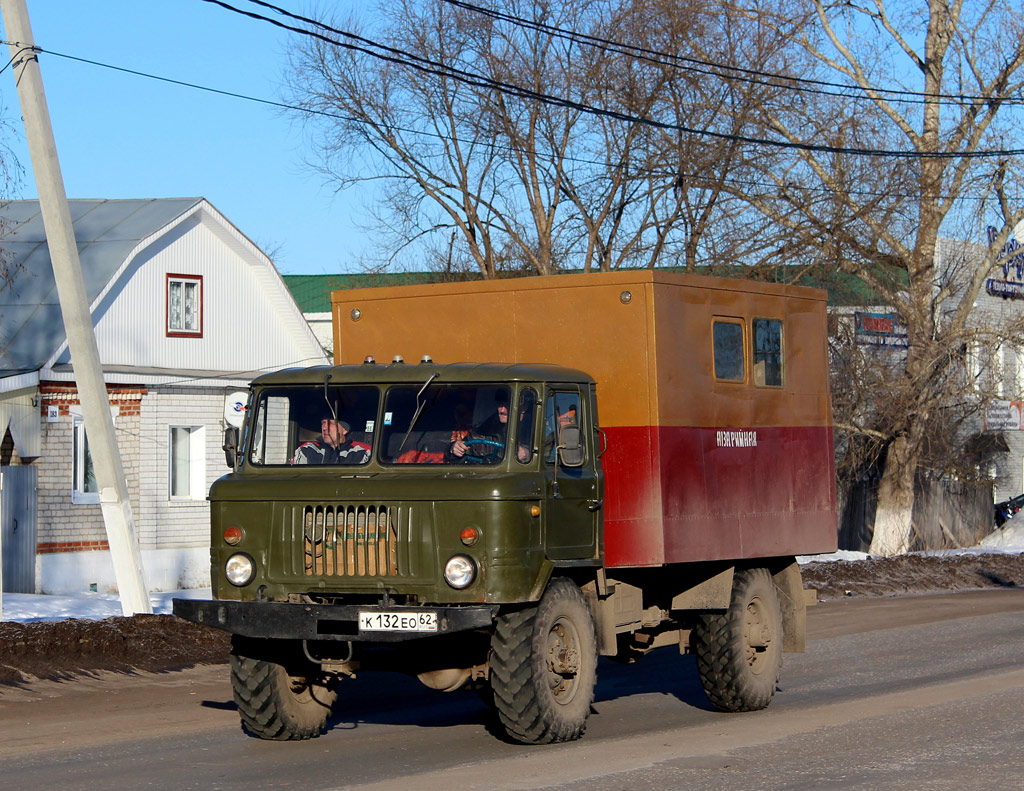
<box><xmin>739</xmin><ymin>0</ymin><xmax>1024</xmax><ymax>555</ymax></box>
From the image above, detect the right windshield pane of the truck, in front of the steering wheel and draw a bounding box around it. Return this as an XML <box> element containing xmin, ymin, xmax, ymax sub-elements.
<box><xmin>381</xmin><ymin>384</ymin><xmax>510</xmax><ymax>464</ymax></box>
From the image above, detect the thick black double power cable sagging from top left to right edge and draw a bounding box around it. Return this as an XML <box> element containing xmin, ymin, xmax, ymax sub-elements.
<box><xmin>203</xmin><ymin>0</ymin><xmax>1024</xmax><ymax>159</ymax></box>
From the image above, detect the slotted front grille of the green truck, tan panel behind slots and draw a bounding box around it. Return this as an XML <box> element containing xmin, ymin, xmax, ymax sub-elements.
<box><xmin>292</xmin><ymin>505</ymin><xmax>410</xmax><ymax>577</ymax></box>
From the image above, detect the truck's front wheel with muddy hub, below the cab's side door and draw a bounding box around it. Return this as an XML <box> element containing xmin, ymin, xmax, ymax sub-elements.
<box><xmin>490</xmin><ymin>578</ymin><xmax>597</xmax><ymax>744</ymax></box>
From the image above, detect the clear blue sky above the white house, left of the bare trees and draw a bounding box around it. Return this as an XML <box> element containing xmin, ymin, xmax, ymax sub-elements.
<box><xmin>0</xmin><ymin>0</ymin><xmax>365</xmax><ymax>275</ymax></box>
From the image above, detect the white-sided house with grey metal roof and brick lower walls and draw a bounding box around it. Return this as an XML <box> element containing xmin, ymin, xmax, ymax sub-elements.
<box><xmin>0</xmin><ymin>199</ymin><xmax>327</xmax><ymax>593</ymax></box>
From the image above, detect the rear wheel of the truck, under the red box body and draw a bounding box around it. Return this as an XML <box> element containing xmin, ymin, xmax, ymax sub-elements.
<box><xmin>694</xmin><ymin>569</ymin><xmax>782</xmax><ymax>711</ymax></box>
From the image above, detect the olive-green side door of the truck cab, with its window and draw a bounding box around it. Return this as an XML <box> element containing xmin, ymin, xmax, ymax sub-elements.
<box><xmin>542</xmin><ymin>384</ymin><xmax>601</xmax><ymax>560</ymax></box>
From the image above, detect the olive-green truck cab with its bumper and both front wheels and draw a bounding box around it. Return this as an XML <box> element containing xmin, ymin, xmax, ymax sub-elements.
<box><xmin>174</xmin><ymin>363</ymin><xmax>603</xmax><ymax>742</ymax></box>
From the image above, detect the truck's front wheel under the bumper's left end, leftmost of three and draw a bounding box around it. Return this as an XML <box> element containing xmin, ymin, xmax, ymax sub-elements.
<box><xmin>230</xmin><ymin>650</ymin><xmax>338</xmax><ymax>741</ymax></box>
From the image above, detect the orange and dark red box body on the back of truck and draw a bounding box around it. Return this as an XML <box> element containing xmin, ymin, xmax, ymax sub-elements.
<box><xmin>332</xmin><ymin>270</ymin><xmax>837</xmax><ymax>569</ymax></box>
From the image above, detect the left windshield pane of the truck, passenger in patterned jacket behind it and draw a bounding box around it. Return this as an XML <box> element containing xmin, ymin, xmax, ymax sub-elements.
<box><xmin>249</xmin><ymin>385</ymin><xmax>380</xmax><ymax>465</ymax></box>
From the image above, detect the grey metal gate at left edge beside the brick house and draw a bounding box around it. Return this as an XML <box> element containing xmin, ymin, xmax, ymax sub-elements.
<box><xmin>0</xmin><ymin>466</ymin><xmax>37</xmax><ymax>593</ymax></box>
